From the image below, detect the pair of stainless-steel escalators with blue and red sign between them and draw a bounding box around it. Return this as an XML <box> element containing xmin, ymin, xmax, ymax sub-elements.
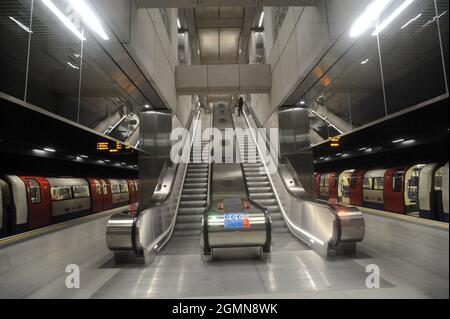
<box><xmin>107</xmin><ymin>105</ymin><xmax>364</xmax><ymax>263</ymax></box>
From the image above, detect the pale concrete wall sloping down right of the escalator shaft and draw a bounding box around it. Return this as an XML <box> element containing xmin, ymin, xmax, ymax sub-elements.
<box><xmin>252</xmin><ymin>0</ymin><xmax>369</xmax><ymax>124</ymax></box>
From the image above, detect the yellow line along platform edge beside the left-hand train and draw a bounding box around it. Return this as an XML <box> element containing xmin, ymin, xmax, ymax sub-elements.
<box><xmin>0</xmin><ymin>205</ymin><xmax>130</xmax><ymax>248</ymax></box>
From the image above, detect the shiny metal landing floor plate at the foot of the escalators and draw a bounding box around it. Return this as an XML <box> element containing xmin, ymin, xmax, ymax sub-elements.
<box><xmin>92</xmin><ymin>233</ymin><xmax>392</xmax><ymax>298</ymax></box>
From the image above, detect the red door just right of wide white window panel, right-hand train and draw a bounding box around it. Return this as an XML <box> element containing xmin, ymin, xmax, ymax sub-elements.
<box><xmin>383</xmin><ymin>168</ymin><xmax>405</xmax><ymax>214</ymax></box>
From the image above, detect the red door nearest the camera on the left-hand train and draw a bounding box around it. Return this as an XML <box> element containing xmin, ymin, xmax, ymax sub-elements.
<box><xmin>20</xmin><ymin>176</ymin><xmax>52</xmax><ymax>230</ymax></box>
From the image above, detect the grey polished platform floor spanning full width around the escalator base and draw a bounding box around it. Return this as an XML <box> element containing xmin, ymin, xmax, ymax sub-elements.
<box><xmin>0</xmin><ymin>214</ymin><xmax>449</xmax><ymax>298</ymax></box>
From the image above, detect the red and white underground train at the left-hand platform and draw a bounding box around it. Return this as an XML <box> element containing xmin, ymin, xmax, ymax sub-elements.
<box><xmin>0</xmin><ymin>175</ymin><xmax>139</xmax><ymax>238</ymax></box>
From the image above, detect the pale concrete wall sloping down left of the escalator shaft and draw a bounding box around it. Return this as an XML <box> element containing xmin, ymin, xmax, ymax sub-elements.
<box><xmin>95</xmin><ymin>0</ymin><xmax>191</xmax><ymax>126</ymax></box>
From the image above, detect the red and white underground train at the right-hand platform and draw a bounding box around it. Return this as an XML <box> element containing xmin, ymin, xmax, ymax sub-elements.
<box><xmin>314</xmin><ymin>163</ymin><xmax>449</xmax><ymax>222</ymax></box>
